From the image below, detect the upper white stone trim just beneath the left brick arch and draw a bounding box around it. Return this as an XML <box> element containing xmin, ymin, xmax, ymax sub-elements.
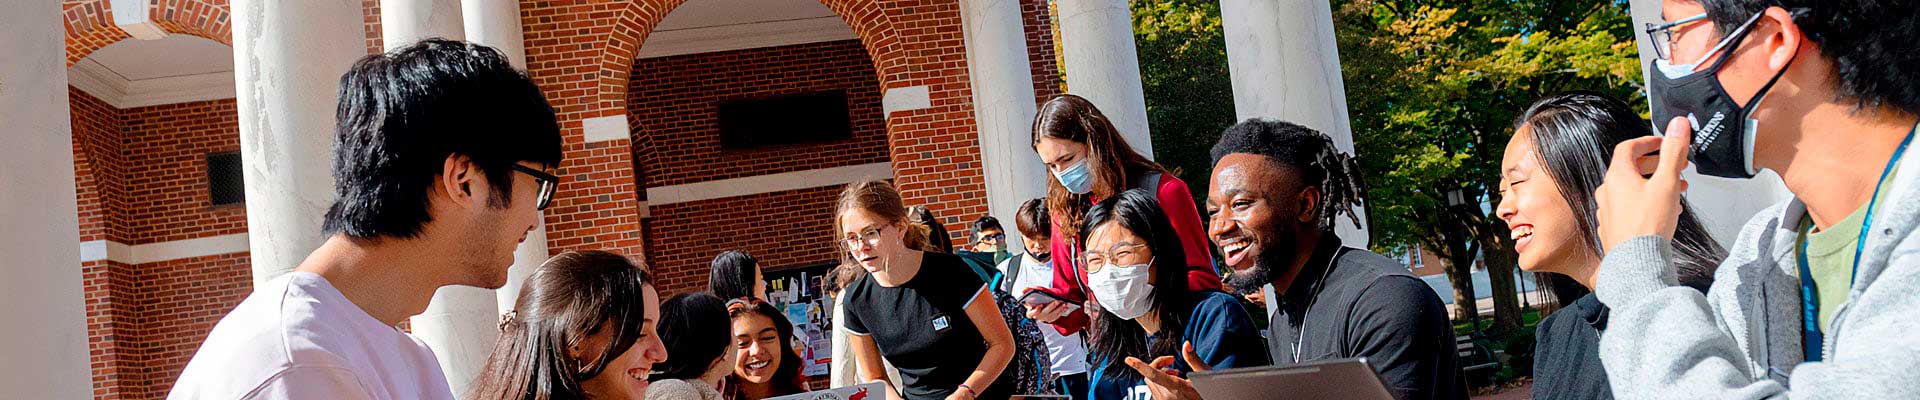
<box><xmin>67</xmin><ymin>58</ymin><xmax>234</xmax><ymax>110</ymax></box>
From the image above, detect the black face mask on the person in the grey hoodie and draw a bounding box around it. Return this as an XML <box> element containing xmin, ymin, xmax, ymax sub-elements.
<box><xmin>1647</xmin><ymin>13</ymin><xmax>1793</xmax><ymax>179</ymax></box>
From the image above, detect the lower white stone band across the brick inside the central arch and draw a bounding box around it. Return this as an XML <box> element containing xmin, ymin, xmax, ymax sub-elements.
<box><xmin>647</xmin><ymin>163</ymin><xmax>893</xmax><ymax>206</ymax></box>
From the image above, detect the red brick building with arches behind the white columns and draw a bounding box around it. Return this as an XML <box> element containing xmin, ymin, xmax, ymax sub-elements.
<box><xmin>52</xmin><ymin>0</ymin><xmax>1062</xmax><ymax>398</ymax></box>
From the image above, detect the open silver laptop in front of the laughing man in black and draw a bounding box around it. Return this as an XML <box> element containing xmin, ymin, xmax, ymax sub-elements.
<box><xmin>1188</xmin><ymin>358</ymin><xmax>1394</xmax><ymax>400</ymax></box>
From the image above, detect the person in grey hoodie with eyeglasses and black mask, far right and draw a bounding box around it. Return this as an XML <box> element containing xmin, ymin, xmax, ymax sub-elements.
<box><xmin>1596</xmin><ymin>0</ymin><xmax>1920</xmax><ymax>398</ymax></box>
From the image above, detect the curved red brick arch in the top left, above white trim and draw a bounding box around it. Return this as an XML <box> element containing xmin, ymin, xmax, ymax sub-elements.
<box><xmin>61</xmin><ymin>0</ymin><xmax>232</xmax><ymax>67</ymax></box>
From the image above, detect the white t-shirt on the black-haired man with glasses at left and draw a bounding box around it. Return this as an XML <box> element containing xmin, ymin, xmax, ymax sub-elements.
<box><xmin>167</xmin><ymin>271</ymin><xmax>453</xmax><ymax>400</ymax></box>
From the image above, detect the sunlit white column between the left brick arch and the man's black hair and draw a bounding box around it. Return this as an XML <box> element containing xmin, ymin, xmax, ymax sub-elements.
<box><xmin>230</xmin><ymin>0</ymin><xmax>367</xmax><ymax>285</ymax></box>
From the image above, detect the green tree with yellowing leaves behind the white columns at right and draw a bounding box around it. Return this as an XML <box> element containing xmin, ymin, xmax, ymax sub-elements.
<box><xmin>1133</xmin><ymin>0</ymin><xmax>1644</xmax><ymax>331</ymax></box>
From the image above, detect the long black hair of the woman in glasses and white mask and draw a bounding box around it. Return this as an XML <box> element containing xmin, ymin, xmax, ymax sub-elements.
<box><xmin>1079</xmin><ymin>188</ymin><xmax>1192</xmax><ymax>381</ymax></box>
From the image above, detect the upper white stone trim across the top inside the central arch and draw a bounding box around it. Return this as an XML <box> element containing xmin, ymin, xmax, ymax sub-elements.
<box><xmin>636</xmin><ymin>15</ymin><xmax>860</xmax><ymax>58</ymax></box>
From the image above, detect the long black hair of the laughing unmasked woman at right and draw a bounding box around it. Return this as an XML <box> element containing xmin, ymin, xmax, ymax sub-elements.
<box><xmin>1513</xmin><ymin>90</ymin><xmax>1726</xmax><ymax>304</ymax></box>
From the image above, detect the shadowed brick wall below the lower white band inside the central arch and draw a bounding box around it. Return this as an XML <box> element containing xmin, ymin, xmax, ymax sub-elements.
<box><xmin>647</xmin><ymin>187</ymin><xmax>841</xmax><ymax>296</ymax></box>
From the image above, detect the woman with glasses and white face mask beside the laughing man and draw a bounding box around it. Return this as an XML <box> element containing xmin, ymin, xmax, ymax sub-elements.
<box><xmin>1081</xmin><ymin>188</ymin><xmax>1269</xmax><ymax>400</ymax></box>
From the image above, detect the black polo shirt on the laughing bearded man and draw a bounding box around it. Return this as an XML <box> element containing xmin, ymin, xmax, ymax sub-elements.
<box><xmin>1267</xmin><ymin>233</ymin><xmax>1467</xmax><ymax>400</ymax></box>
